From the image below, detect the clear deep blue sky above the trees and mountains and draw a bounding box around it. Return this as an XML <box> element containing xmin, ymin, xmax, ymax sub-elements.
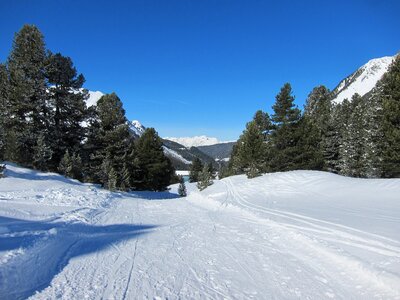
<box><xmin>0</xmin><ymin>0</ymin><xmax>400</xmax><ymax>140</ymax></box>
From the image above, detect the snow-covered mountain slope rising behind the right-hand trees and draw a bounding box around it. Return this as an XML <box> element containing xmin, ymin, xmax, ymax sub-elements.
<box><xmin>332</xmin><ymin>56</ymin><xmax>395</xmax><ymax>103</ymax></box>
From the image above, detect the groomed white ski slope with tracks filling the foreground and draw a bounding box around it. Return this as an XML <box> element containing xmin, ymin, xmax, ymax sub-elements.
<box><xmin>0</xmin><ymin>165</ymin><xmax>400</xmax><ymax>299</ymax></box>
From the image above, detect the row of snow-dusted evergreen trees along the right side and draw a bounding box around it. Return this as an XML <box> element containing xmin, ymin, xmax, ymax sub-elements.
<box><xmin>220</xmin><ymin>55</ymin><xmax>400</xmax><ymax>178</ymax></box>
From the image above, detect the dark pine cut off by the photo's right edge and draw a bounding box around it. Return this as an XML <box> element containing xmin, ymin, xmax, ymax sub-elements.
<box><xmin>380</xmin><ymin>54</ymin><xmax>400</xmax><ymax>177</ymax></box>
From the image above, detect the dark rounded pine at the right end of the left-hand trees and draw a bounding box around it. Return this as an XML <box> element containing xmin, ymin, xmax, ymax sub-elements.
<box><xmin>135</xmin><ymin>128</ymin><xmax>175</xmax><ymax>191</ymax></box>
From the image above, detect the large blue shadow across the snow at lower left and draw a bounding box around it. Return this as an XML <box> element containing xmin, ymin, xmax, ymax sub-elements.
<box><xmin>0</xmin><ymin>217</ymin><xmax>157</xmax><ymax>299</ymax></box>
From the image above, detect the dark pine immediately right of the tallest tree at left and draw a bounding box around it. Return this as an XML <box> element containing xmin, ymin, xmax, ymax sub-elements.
<box><xmin>46</xmin><ymin>53</ymin><xmax>88</xmax><ymax>168</ymax></box>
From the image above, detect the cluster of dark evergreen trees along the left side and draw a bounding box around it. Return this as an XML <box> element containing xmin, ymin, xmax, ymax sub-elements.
<box><xmin>0</xmin><ymin>25</ymin><xmax>177</xmax><ymax>191</ymax></box>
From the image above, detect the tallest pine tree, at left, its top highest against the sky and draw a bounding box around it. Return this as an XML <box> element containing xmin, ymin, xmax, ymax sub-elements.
<box><xmin>5</xmin><ymin>25</ymin><xmax>48</xmax><ymax>166</ymax></box>
